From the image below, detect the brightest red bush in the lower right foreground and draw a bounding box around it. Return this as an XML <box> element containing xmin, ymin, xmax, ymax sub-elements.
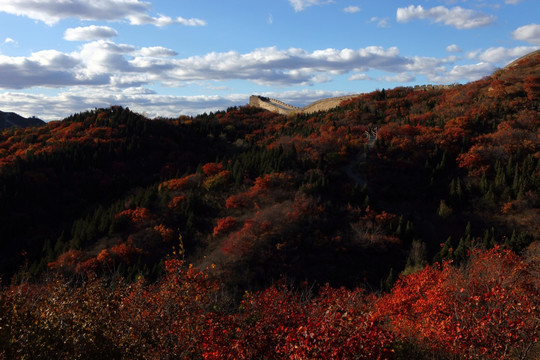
<box><xmin>377</xmin><ymin>248</ymin><xmax>540</xmax><ymax>359</ymax></box>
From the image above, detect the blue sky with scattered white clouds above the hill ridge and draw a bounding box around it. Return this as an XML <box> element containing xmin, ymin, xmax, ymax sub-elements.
<box><xmin>0</xmin><ymin>0</ymin><xmax>540</xmax><ymax>121</ymax></box>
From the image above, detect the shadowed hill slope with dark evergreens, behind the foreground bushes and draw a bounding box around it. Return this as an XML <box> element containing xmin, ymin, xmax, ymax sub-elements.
<box><xmin>0</xmin><ymin>50</ymin><xmax>540</xmax><ymax>294</ymax></box>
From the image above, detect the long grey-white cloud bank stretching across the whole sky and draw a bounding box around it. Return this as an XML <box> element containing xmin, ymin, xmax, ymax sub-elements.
<box><xmin>0</xmin><ymin>40</ymin><xmax>539</xmax><ymax>90</ymax></box>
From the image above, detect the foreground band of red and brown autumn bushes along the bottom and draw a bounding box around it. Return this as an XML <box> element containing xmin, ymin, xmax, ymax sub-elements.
<box><xmin>0</xmin><ymin>247</ymin><xmax>540</xmax><ymax>359</ymax></box>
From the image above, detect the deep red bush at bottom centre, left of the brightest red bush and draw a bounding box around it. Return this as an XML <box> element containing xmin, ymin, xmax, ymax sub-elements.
<box><xmin>205</xmin><ymin>285</ymin><xmax>392</xmax><ymax>359</ymax></box>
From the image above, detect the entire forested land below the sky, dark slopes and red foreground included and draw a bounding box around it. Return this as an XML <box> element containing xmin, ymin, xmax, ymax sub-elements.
<box><xmin>0</xmin><ymin>52</ymin><xmax>540</xmax><ymax>359</ymax></box>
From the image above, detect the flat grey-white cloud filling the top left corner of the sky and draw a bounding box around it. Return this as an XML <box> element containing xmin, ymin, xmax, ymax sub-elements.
<box><xmin>0</xmin><ymin>0</ymin><xmax>206</xmax><ymax>26</ymax></box>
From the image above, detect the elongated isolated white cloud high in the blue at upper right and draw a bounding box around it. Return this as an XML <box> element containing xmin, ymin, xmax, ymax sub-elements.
<box><xmin>396</xmin><ymin>5</ymin><xmax>495</xmax><ymax>29</ymax></box>
